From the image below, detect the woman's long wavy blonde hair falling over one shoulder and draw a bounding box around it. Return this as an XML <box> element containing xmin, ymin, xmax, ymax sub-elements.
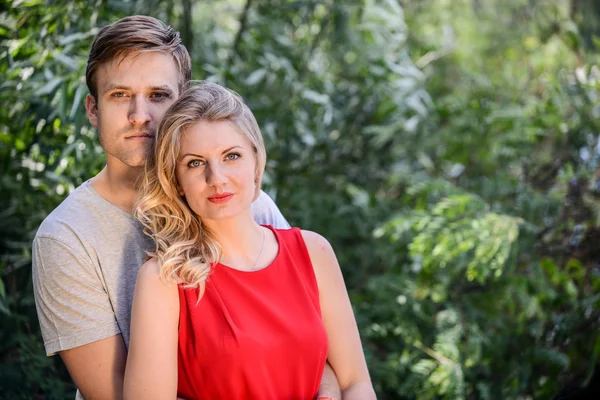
<box><xmin>134</xmin><ymin>81</ymin><xmax>266</xmax><ymax>296</ymax></box>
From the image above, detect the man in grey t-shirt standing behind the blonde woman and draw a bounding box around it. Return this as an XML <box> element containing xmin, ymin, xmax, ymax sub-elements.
<box><xmin>33</xmin><ymin>16</ymin><xmax>339</xmax><ymax>399</ymax></box>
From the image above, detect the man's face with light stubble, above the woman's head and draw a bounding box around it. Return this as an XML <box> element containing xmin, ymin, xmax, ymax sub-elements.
<box><xmin>86</xmin><ymin>52</ymin><xmax>179</xmax><ymax>167</ymax></box>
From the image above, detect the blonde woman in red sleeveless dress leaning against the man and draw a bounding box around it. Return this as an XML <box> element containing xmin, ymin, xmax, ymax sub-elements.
<box><xmin>124</xmin><ymin>83</ymin><xmax>375</xmax><ymax>400</ymax></box>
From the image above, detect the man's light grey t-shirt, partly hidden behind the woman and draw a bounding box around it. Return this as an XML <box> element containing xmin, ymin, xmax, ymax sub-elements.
<box><xmin>32</xmin><ymin>182</ymin><xmax>289</xmax><ymax>355</ymax></box>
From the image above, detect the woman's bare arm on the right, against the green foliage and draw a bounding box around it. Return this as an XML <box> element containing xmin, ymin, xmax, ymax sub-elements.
<box><xmin>302</xmin><ymin>231</ymin><xmax>376</xmax><ymax>400</ymax></box>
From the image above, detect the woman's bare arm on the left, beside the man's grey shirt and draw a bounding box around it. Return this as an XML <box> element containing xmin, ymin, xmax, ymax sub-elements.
<box><xmin>123</xmin><ymin>260</ymin><xmax>179</xmax><ymax>400</ymax></box>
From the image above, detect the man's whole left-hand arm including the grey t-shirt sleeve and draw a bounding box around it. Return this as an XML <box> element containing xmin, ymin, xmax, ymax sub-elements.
<box><xmin>32</xmin><ymin>236</ymin><xmax>127</xmax><ymax>400</ymax></box>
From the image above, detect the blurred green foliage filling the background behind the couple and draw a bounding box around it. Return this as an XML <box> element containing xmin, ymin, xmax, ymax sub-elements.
<box><xmin>0</xmin><ymin>0</ymin><xmax>600</xmax><ymax>399</ymax></box>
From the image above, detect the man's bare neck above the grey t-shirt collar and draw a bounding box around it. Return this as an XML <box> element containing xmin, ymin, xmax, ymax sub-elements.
<box><xmin>90</xmin><ymin>164</ymin><xmax>144</xmax><ymax>213</ymax></box>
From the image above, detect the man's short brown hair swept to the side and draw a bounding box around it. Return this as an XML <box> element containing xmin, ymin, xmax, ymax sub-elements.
<box><xmin>85</xmin><ymin>15</ymin><xmax>192</xmax><ymax>97</ymax></box>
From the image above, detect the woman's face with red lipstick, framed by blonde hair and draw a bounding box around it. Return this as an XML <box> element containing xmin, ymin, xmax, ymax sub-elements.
<box><xmin>176</xmin><ymin>121</ymin><xmax>256</xmax><ymax>221</ymax></box>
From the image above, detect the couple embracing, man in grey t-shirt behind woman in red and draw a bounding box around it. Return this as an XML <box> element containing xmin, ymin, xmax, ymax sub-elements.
<box><xmin>33</xmin><ymin>16</ymin><xmax>375</xmax><ymax>399</ymax></box>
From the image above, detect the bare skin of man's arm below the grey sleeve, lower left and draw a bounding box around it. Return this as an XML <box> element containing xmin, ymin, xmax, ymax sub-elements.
<box><xmin>58</xmin><ymin>335</ymin><xmax>127</xmax><ymax>400</ymax></box>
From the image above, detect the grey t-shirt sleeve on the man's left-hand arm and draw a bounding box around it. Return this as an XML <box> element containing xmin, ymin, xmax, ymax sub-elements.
<box><xmin>32</xmin><ymin>237</ymin><xmax>121</xmax><ymax>355</ymax></box>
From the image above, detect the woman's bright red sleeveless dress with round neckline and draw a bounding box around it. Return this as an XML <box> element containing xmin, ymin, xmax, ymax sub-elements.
<box><xmin>177</xmin><ymin>226</ymin><xmax>327</xmax><ymax>400</ymax></box>
